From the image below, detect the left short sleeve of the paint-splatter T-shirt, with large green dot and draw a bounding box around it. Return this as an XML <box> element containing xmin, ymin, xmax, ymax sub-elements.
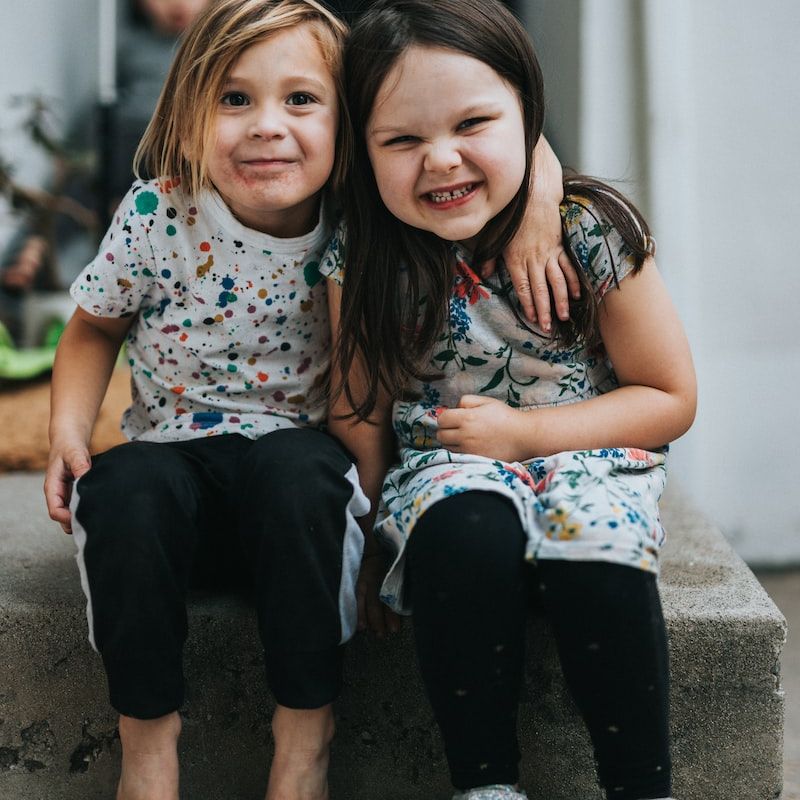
<box><xmin>70</xmin><ymin>182</ymin><xmax>164</xmax><ymax>317</ymax></box>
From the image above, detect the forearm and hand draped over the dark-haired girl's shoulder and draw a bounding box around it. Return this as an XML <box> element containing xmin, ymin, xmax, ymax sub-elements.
<box><xmin>484</xmin><ymin>136</ymin><xmax>580</xmax><ymax>332</ymax></box>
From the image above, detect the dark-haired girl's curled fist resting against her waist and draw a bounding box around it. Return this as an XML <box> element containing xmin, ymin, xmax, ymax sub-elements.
<box><xmin>437</xmin><ymin>394</ymin><xmax>530</xmax><ymax>461</ymax></box>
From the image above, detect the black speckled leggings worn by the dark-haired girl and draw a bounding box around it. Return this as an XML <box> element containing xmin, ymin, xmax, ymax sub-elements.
<box><xmin>406</xmin><ymin>492</ymin><xmax>671</xmax><ymax>800</ymax></box>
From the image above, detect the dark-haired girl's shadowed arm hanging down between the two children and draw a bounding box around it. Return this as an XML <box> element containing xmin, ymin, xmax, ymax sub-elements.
<box><xmin>328</xmin><ymin>280</ymin><xmax>400</xmax><ymax>635</ymax></box>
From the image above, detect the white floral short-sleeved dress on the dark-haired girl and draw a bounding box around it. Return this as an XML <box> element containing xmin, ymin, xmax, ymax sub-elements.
<box><xmin>322</xmin><ymin>200</ymin><xmax>667</xmax><ymax>612</ymax></box>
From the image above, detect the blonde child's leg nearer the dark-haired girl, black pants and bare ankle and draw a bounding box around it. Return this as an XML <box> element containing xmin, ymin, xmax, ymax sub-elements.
<box><xmin>238</xmin><ymin>429</ymin><xmax>366</xmax><ymax>800</ymax></box>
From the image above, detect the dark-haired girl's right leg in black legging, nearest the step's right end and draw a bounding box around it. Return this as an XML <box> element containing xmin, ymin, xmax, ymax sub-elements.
<box><xmin>538</xmin><ymin>561</ymin><xmax>671</xmax><ymax>800</ymax></box>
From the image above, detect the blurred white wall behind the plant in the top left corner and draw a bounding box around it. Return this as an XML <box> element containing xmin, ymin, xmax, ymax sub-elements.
<box><xmin>0</xmin><ymin>0</ymin><xmax>100</xmax><ymax>245</ymax></box>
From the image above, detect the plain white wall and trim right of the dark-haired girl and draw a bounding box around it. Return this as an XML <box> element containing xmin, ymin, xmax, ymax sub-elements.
<box><xmin>528</xmin><ymin>0</ymin><xmax>800</xmax><ymax>564</ymax></box>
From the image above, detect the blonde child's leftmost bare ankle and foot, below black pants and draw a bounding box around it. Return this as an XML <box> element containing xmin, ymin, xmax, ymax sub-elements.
<box><xmin>117</xmin><ymin>711</ymin><xmax>181</xmax><ymax>800</ymax></box>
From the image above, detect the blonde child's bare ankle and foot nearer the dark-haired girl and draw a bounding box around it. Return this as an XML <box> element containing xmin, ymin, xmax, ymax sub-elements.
<box><xmin>266</xmin><ymin>705</ymin><xmax>334</xmax><ymax>800</ymax></box>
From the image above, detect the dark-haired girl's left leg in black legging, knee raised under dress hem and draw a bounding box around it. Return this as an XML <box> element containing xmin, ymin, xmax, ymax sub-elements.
<box><xmin>406</xmin><ymin>492</ymin><xmax>530</xmax><ymax>790</ymax></box>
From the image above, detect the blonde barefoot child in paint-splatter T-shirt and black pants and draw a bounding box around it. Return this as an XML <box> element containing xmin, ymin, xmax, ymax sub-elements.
<box><xmin>45</xmin><ymin>0</ymin><xmax>360</xmax><ymax>800</ymax></box>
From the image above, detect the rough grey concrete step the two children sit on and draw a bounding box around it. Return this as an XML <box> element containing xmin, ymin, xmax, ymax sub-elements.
<box><xmin>0</xmin><ymin>474</ymin><xmax>786</xmax><ymax>800</ymax></box>
